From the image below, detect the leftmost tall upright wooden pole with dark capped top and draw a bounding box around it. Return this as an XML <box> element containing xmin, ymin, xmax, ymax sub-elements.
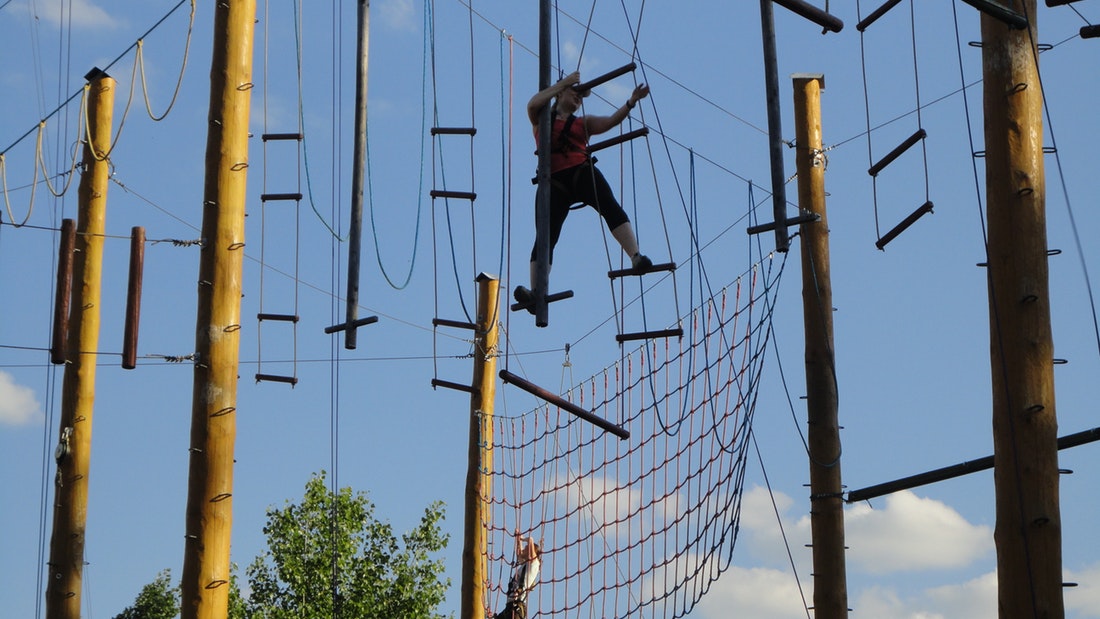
<box><xmin>46</xmin><ymin>69</ymin><xmax>114</xmax><ymax>619</ymax></box>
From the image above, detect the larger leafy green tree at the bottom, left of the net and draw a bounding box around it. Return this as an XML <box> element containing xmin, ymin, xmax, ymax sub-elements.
<box><xmin>246</xmin><ymin>472</ymin><xmax>450</xmax><ymax>619</ymax></box>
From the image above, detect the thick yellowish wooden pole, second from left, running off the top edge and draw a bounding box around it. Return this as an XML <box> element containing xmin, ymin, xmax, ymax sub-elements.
<box><xmin>180</xmin><ymin>0</ymin><xmax>256</xmax><ymax>619</ymax></box>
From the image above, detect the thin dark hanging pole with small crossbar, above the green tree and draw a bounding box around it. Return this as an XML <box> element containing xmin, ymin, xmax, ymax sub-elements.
<box><xmin>344</xmin><ymin>0</ymin><xmax>371</xmax><ymax>351</ymax></box>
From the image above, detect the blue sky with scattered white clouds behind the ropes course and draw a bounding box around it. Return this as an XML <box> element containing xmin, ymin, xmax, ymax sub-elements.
<box><xmin>0</xmin><ymin>0</ymin><xmax>1100</xmax><ymax>619</ymax></box>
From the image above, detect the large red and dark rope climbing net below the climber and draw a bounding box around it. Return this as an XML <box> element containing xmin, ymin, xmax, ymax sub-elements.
<box><xmin>483</xmin><ymin>251</ymin><xmax>782</xmax><ymax>619</ymax></box>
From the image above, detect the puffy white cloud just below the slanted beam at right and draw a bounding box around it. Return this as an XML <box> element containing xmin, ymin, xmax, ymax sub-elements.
<box><xmin>845</xmin><ymin>491</ymin><xmax>993</xmax><ymax>574</ymax></box>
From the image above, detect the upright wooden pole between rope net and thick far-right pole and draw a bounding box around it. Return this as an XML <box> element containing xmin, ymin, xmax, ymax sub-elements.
<box><xmin>793</xmin><ymin>75</ymin><xmax>848</xmax><ymax>619</ymax></box>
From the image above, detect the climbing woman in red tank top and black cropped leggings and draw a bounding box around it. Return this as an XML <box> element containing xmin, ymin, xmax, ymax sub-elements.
<box><xmin>513</xmin><ymin>71</ymin><xmax>653</xmax><ymax>313</ymax></box>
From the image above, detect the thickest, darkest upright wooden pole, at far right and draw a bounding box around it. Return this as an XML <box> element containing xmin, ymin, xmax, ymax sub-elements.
<box><xmin>981</xmin><ymin>0</ymin><xmax>1065</xmax><ymax>619</ymax></box>
